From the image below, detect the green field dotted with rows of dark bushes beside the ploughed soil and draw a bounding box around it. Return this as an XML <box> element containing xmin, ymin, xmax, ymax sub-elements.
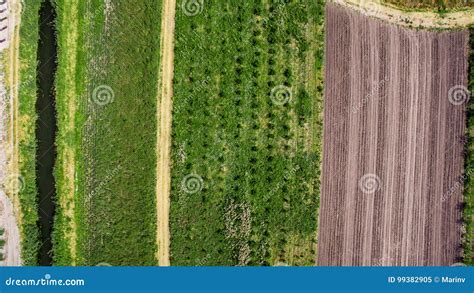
<box><xmin>170</xmin><ymin>0</ymin><xmax>324</xmax><ymax>265</ymax></box>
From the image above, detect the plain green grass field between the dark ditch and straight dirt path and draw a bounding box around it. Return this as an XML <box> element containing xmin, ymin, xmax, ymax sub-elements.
<box><xmin>55</xmin><ymin>0</ymin><xmax>161</xmax><ymax>265</ymax></box>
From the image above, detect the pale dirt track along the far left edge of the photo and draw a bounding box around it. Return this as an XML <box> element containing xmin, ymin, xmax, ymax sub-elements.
<box><xmin>0</xmin><ymin>1</ymin><xmax>22</xmax><ymax>266</ymax></box>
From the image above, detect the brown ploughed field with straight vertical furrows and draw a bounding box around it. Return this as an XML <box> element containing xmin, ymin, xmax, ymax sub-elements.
<box><xmin>318</xmin><ymin>4</ymin><xmax>469</xmax><ymax>266</ymax></box>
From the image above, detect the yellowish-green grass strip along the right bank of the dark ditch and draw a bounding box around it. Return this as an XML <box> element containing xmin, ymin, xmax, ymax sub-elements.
<box><xmin>53</xmin><ymin>0</ymin><xmax>80</xmax><ymax>265</ymax></box>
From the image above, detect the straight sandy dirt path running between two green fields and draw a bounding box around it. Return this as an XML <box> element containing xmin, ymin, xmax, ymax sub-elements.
<box><xmin>156</xmin><ymin>0</ymin><xmax>176</xmax><ymax>266</ymax></box>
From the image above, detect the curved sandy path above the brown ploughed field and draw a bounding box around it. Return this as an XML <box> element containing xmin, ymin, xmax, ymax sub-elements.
<box><xmin>331</xmin><ymin>0</ymin><xmax>474</xmax><ymax>29</ymax></box>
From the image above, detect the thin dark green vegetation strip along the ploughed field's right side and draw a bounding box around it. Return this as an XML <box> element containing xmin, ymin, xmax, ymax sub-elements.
<box><xmin>463</xmin><ymin>27</ymin><xmax>474</xmax><ymax>266</ymax></box>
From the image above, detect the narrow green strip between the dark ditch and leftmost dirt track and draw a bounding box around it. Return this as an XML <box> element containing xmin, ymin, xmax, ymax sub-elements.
<box><xmin>18</xmin><ymin>0</ymin><xmax>41</xmax><ymax>265</ymax></box>
